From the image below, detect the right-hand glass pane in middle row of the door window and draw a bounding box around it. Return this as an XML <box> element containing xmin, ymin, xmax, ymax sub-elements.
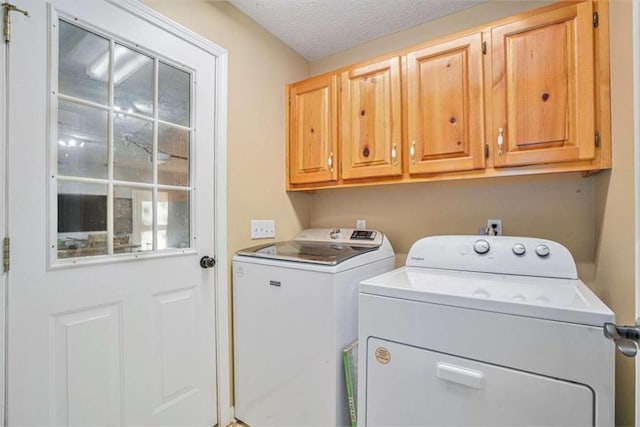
<box><xmin>158</xmin><ymin>123</ymin><xmax>190</xmax><ymax>187</ymax></box>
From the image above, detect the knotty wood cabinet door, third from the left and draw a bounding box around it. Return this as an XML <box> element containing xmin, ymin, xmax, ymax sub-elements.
<box><xmin>407</xmin><ymin>33</ymin><xmax>485</xmax><ymax>174</ymax></box>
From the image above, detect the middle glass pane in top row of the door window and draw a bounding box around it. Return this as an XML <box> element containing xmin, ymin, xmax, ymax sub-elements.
<box><xmin>113</xmin><ymin>44</ymin><xmax>153</xmax><ymax>117</ymax></box>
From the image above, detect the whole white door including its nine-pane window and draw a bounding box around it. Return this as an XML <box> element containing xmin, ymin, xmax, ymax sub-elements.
<box><xmin>6</xmin><ymin>0</ymin><xmax>224</xmax><ymax>426</ymax></box>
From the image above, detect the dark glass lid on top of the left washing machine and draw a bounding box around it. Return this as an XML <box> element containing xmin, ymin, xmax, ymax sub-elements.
<box><xmin>237</xmin><ymin>241</ymin><xmax>378</xmax><ymax>265</ymax></box>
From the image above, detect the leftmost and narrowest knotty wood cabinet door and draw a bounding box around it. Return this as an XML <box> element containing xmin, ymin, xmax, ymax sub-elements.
<box><xmin>288</xmin><ymin>75</ymin><xmax>338</xmax><ymax>184</ymax></box>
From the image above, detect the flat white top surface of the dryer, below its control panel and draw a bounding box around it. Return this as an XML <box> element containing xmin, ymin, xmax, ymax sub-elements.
<box><xmin>360</xmin><ymin>267</ymin><xmax>614</xmax><ymax>326</ymax></box>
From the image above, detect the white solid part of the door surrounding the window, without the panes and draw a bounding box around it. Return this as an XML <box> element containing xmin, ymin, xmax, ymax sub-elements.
<box><xmin>7</xmin><ymin>0</ymin><xmax>217</xmax><ymax>426</ymax></box>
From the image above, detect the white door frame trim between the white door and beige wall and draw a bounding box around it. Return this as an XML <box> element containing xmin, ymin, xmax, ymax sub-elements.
<box><xmin>105</xmin><ymin>0</ymin><xmax>234</xmax><ymax>426</ymax></box>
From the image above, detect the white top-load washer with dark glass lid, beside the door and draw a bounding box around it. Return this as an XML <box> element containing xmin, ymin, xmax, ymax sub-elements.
<box><xmin>233</xmin><ymin>228</ymin><xmax>395</xmax><ymax>427</ymax></box>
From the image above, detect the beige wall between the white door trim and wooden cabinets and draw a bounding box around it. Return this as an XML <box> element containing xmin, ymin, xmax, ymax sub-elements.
<box><xmin>144</xmin><ymin>0</ymin><xmax>310</xmax><ymax>266</ymax></box>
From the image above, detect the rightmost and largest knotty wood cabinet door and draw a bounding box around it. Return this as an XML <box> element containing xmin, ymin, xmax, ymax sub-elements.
<box><xmin>491</xmin><ymin>1</ymin><xmax>595</xmax><ymax>167</ymax></box>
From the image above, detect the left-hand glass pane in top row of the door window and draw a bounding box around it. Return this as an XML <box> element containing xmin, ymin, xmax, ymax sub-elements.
<box><xmin>58</xmin><ymin>21</ymin><xmax>109</xmax><ymax>105</ymax></box>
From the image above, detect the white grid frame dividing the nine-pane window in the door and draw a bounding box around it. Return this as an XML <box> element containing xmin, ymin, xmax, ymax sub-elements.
<box><xmin>47</xmin><ymin>11</ymin><xmax>197</xmax><ymax>268</ymax></box>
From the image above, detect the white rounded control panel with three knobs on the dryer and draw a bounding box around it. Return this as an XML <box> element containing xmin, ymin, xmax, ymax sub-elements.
<box><xmin>406</xmin><ymin>236</ymin><xmax>578</xmax><ymax>279</ymax></box>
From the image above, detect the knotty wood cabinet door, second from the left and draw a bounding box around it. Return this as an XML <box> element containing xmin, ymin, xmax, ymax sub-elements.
<box><xmin>340</xmin><ymin>57</ymin><xmax>402</xmax><ymax>179</ymax></box>
